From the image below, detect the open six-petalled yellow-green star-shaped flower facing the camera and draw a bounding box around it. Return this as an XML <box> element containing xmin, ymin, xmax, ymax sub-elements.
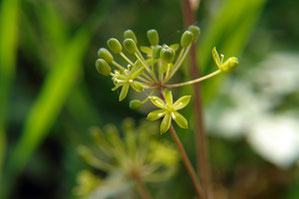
<box><xmin>147</xmin><ymin>89</ymin><xmax>191</xmax><ymax>134</ymax></box>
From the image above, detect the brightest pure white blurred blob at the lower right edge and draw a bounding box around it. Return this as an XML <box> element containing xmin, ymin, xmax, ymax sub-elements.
<box><xmin>247</xmin><ymin>116</ymin><xmax>299</xmax><ymax>168</ymax></box>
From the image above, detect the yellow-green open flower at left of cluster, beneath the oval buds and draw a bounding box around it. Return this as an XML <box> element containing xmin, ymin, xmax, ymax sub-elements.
<box><xmin>112</xmin><ymin>62</ymin><xmax>144</xmax><ymax>101</ymax></box>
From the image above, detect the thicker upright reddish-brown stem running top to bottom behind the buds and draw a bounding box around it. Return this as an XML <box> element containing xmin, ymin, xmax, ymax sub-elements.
<box><xmin>181</xmin><ymin>0</ymin><xmax>213</xmax><ymax>199</ymax></box>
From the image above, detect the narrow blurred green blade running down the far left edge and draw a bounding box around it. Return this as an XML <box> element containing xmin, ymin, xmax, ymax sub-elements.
<box><xmin>0</xmin><ymin>0</ymin><xmax>21</xmax><ymax>185</ymax></box>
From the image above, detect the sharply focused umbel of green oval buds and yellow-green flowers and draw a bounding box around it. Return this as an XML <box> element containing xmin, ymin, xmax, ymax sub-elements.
<box><xmin>96</xmin><ymin>25</ymin><xmax>238</xmax><ymax>133</ymax></box>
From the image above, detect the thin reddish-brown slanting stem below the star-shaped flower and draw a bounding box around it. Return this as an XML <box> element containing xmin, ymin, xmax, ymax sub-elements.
<box><xmin>169</xmin><ymin>125</ymin><xmax>204</xmax><ymax>198</ymax></box>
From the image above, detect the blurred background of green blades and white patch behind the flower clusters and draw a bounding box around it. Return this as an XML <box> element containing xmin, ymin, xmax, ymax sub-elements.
<box><xmin>0</xmin><ymin>0</ymin><xmax>299</xmax><ymax>199</ymax></box>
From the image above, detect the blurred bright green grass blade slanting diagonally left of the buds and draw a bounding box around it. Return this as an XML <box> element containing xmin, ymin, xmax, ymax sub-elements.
<box><xmin>0</xmin><ymin>3</ymin><xmax>111</xmax><ymax>198</ymax></box>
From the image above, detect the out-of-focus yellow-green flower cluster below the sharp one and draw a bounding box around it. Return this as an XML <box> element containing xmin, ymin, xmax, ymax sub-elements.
<box><xmin>74</xmin><ymin>119</ymin><xmax>179</xmax><ymax>198</ymax></box>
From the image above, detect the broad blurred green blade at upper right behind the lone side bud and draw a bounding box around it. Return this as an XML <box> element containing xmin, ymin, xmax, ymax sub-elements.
<box><xmin>198</xmin><ymin>0</ymin><xmax>266</xmax><ymax>102</ymax></box>
